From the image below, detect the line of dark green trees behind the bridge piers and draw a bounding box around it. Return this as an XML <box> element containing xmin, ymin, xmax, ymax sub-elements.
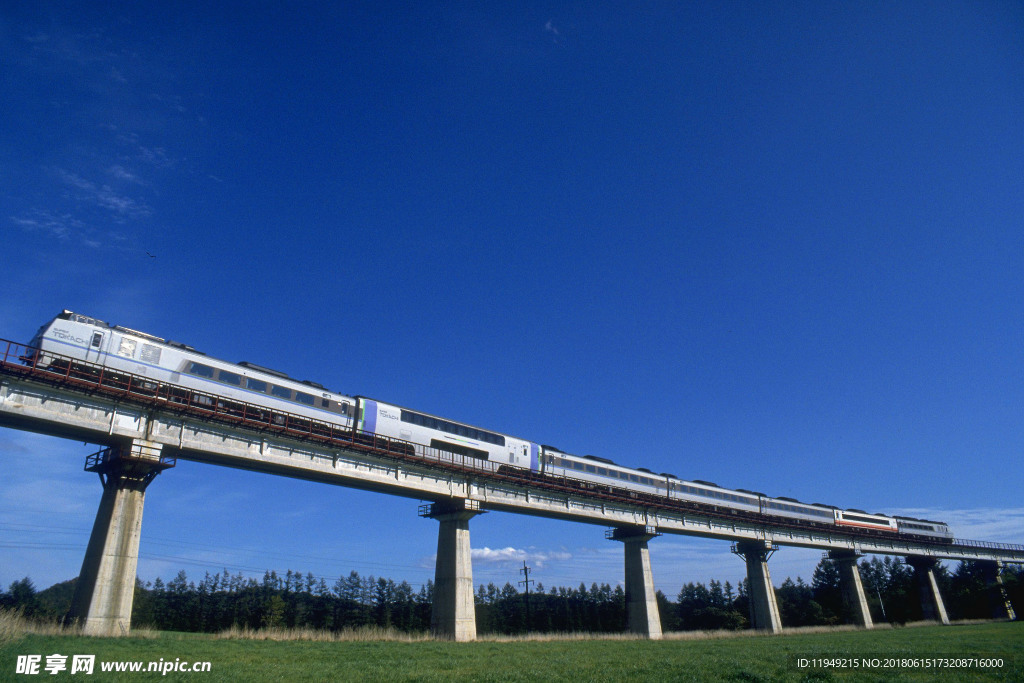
<box><xmin>0</xmin><ymin>557</ymin><xmax>1024</xmax><ymax>634</ymax></box>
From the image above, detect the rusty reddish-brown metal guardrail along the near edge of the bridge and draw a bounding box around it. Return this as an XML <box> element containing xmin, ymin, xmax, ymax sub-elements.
<box><xmin>6</xmin><ymin>339</ymin><xmax>1024</xmax><ymax>560</ymax></box>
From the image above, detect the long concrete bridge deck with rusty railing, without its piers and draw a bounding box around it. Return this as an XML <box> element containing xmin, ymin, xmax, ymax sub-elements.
<box><xmin>0</xmin><ymin>340</ymin><xmax>1024</xmax><ymax>563</ymax></box>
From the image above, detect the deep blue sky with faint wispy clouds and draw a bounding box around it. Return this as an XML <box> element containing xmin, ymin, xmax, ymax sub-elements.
<box><xmin>0</xmin><ymin>2</ymin><xmax>1024</xmax><ymax>595</ymax></box>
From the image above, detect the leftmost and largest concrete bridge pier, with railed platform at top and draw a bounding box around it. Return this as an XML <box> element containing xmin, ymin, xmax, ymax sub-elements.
<box><xmin>68</xmin><ymin>439</ymin><xmax>174</xmax><ymax>636</ymax></box>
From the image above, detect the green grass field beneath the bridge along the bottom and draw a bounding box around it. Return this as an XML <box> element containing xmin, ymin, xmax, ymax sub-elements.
<box><xmin>0</xmin><ymin>623</ymin><xmax>1024</xmax><ymax>681</ymax></box>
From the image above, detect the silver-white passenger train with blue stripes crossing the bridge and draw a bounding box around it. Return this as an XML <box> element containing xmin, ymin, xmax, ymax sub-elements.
<box><xmin>22</xmin><ymin>310</ymin><xmax>953</xmax><ymax>544</ymax></box>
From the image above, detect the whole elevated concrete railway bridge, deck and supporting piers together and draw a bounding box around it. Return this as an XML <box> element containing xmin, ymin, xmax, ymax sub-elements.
<box><xmin>0</xmin><ymin>340</ymin><xmax>1024</xmax><ymax>640</ymax></box>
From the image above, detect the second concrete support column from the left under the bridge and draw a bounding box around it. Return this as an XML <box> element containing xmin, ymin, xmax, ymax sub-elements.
<box><xmin>421</xmin><ymin>500</ymin><xmax>480</xmax><ymax>642</ymax></box>
